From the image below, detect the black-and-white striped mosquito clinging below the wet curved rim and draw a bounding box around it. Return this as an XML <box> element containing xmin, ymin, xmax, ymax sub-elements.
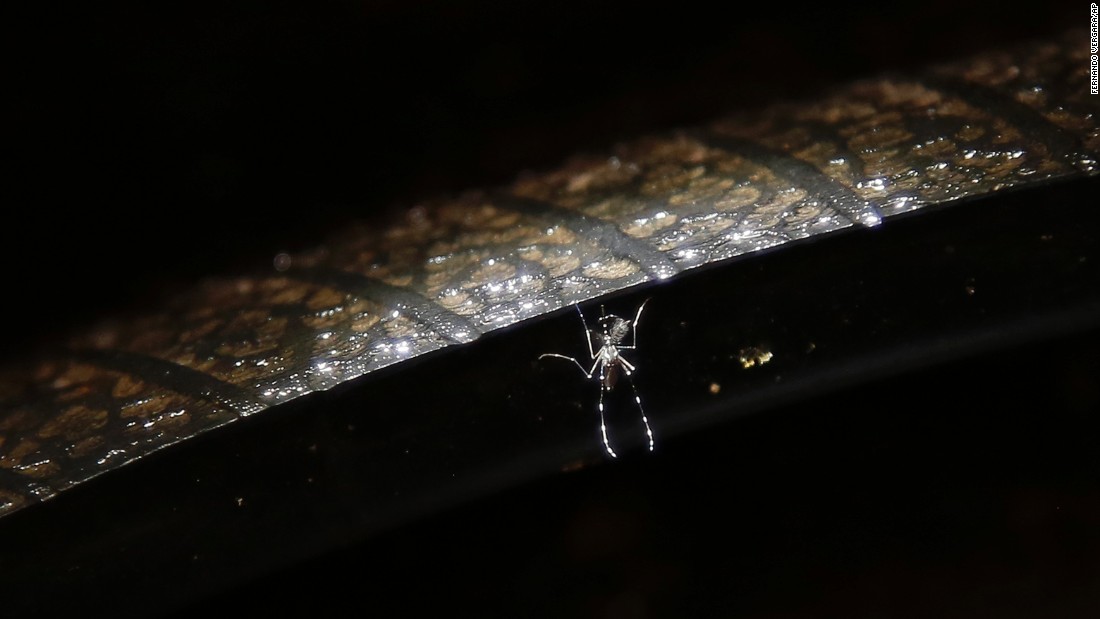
<box><xmin>539</xmin><ymin>299</ymin><xmax>653</xmax><ymax>457</ymax></box>
